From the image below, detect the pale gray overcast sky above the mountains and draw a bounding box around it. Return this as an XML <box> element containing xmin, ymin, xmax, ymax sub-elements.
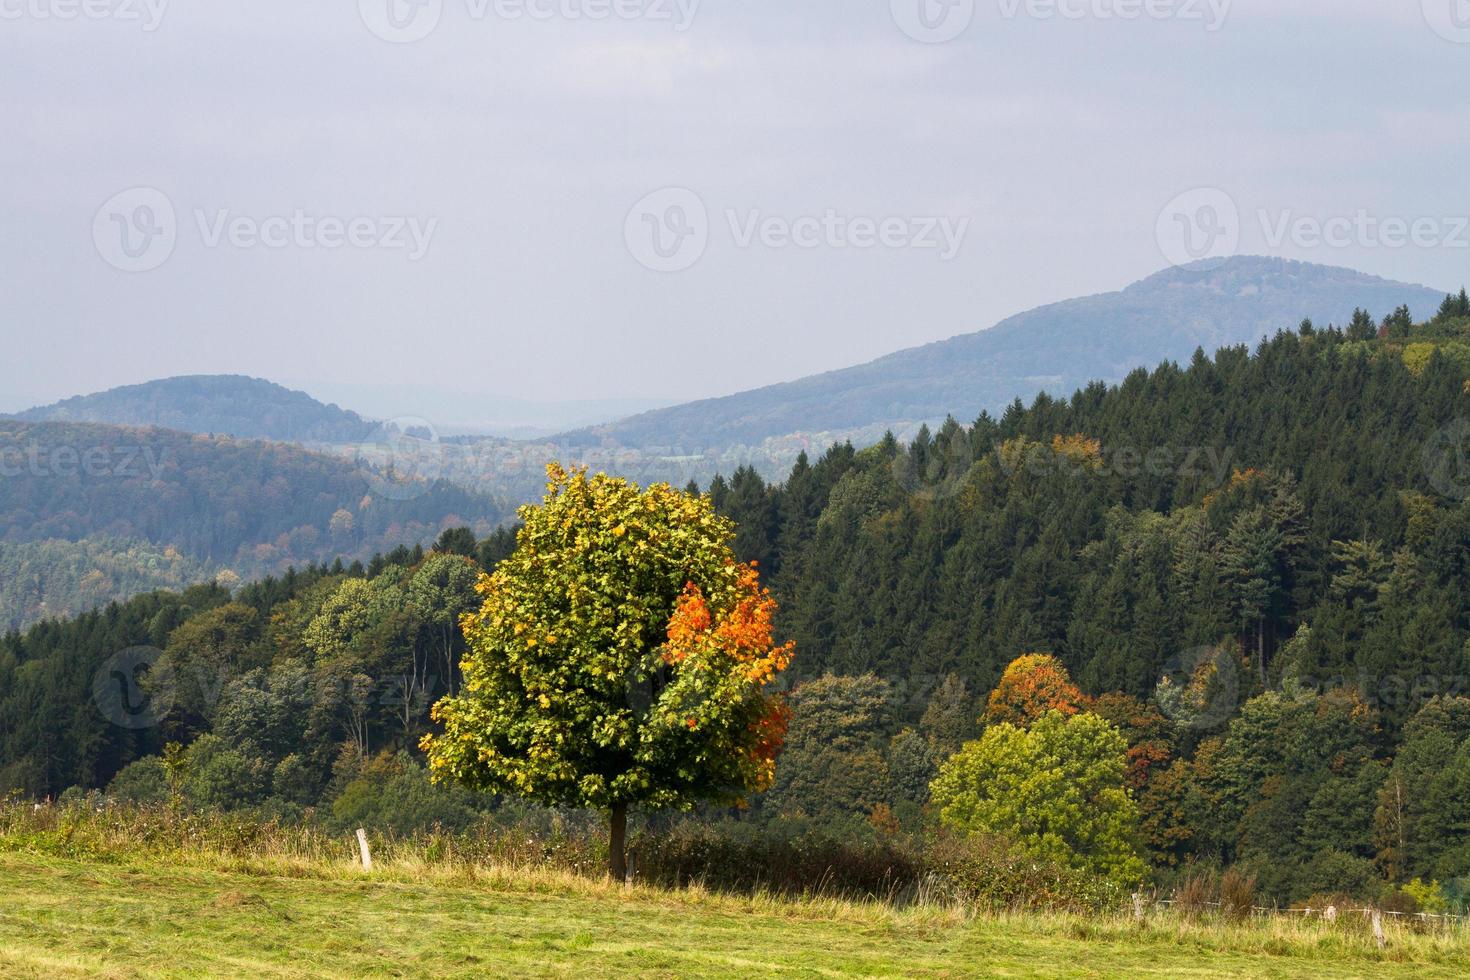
<box><xmin>0</xmin><ymin>0</ymin><xmax>1470</xmax><ymax>417</ymax></box>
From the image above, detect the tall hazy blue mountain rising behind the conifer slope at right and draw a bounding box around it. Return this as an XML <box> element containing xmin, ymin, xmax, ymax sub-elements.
<box><xmin>556</xmin><ymin>257</ymin><xmax>1445</xmax><ymax>453</ymax></box>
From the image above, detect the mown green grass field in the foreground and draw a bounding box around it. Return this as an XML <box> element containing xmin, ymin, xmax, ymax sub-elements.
<box><xmin>0</xmin><ymin>851</ymin><xmax>1470</xmax><ymax>977</ymax></box>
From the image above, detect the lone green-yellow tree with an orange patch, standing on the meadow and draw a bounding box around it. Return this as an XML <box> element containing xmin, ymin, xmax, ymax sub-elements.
<box><xmin>423</xmin><ymin>464</ymin><xmax>794</xmax><ymax>880</ymax></box>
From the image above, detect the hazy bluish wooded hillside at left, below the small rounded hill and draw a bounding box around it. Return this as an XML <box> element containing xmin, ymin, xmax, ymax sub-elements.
<box><xmin>0</xmin><ymin>419</ymin><xmax>503</xmax><ymax>627</ymax></box>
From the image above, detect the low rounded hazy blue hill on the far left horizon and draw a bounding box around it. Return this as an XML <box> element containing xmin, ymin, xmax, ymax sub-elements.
<box><xmin>16</xmin><ymin>375</ymin><xmax>376</xmax><ymax>442</ymax></box>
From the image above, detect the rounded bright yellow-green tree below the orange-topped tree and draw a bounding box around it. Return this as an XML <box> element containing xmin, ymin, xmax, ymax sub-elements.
<box><xmin>932</xmin><ymin>711</ymin><xmax>1147</xmax><ymax>884</ymax></box>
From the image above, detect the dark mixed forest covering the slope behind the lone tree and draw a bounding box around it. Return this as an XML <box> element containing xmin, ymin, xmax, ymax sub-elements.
<box><xmin>0</xmin><ymin>292</ymin><xmax>1470</xmax><ymax>908</ymax></box>
